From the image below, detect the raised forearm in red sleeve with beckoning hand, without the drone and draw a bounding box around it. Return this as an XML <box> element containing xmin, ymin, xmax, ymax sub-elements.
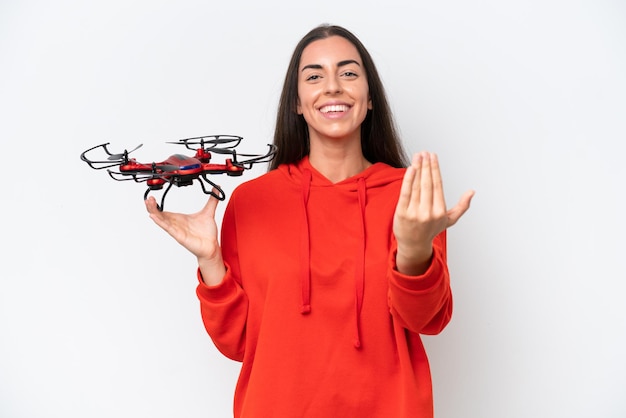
<box><xmin>389</xmin><ymin>153</ymin><xmax>474</xmax><ymax>334</ymax></box>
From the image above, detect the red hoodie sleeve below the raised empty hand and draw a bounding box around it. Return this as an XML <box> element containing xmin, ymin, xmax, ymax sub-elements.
<box><xmin>388</xmin><ymin>231</ymin><xmax>452</xmax><ymax>335</ymax></box>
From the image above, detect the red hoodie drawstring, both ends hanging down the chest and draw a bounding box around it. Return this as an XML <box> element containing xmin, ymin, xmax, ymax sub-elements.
<box><xmin>300</xmin><ymin>169</ymin><xmax>367</xmax><ymax>348</ymax></box>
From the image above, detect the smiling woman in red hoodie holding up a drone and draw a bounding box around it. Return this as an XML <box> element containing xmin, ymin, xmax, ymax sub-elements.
<box><xmin>146</xmin><ymin>26</ymin><xmax>473</xmax><ymax>418</ymax></box>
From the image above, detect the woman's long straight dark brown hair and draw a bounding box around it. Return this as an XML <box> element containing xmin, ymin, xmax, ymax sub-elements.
<box><xmin>269</xmin><ymin>25</ymin><xmax>408</xmax><ymax>170</ymax></box>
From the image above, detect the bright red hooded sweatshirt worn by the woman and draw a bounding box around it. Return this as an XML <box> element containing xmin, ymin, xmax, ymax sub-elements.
<box><xmin>197</xmin><ymin>158</ymin><xmax>452</xmax><ymax>418</ymax></box>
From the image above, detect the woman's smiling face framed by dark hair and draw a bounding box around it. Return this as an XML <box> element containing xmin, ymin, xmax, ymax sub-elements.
<box><xmin>297</xmin><ymin>36</ymin><xmax>372</xmax><ymax>144</ymax></box>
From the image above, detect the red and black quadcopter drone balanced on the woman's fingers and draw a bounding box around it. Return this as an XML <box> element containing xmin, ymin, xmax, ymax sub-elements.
<box><xmin>80</xmin><ymin>135</ymin><xmax>276</xmax><ymax>211</ymax></box>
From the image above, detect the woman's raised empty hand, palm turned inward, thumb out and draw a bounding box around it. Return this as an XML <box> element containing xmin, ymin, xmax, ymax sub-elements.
<box><xmin>393</xmin><ymin>152</ymin><xmax>474</xmax><ymax>276</ymax></box>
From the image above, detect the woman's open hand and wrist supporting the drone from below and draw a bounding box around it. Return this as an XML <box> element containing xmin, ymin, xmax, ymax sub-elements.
<box><xmin>145</xmin><ymin>192</ymin><xmax>226</xmax><ymax>284</ymax></box>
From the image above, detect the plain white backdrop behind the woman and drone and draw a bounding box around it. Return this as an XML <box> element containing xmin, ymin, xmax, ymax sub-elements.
<box><xmin>0</xmin><ymin>0</ymin><xmax>626</xmax><ymax>418</ymax></box>
